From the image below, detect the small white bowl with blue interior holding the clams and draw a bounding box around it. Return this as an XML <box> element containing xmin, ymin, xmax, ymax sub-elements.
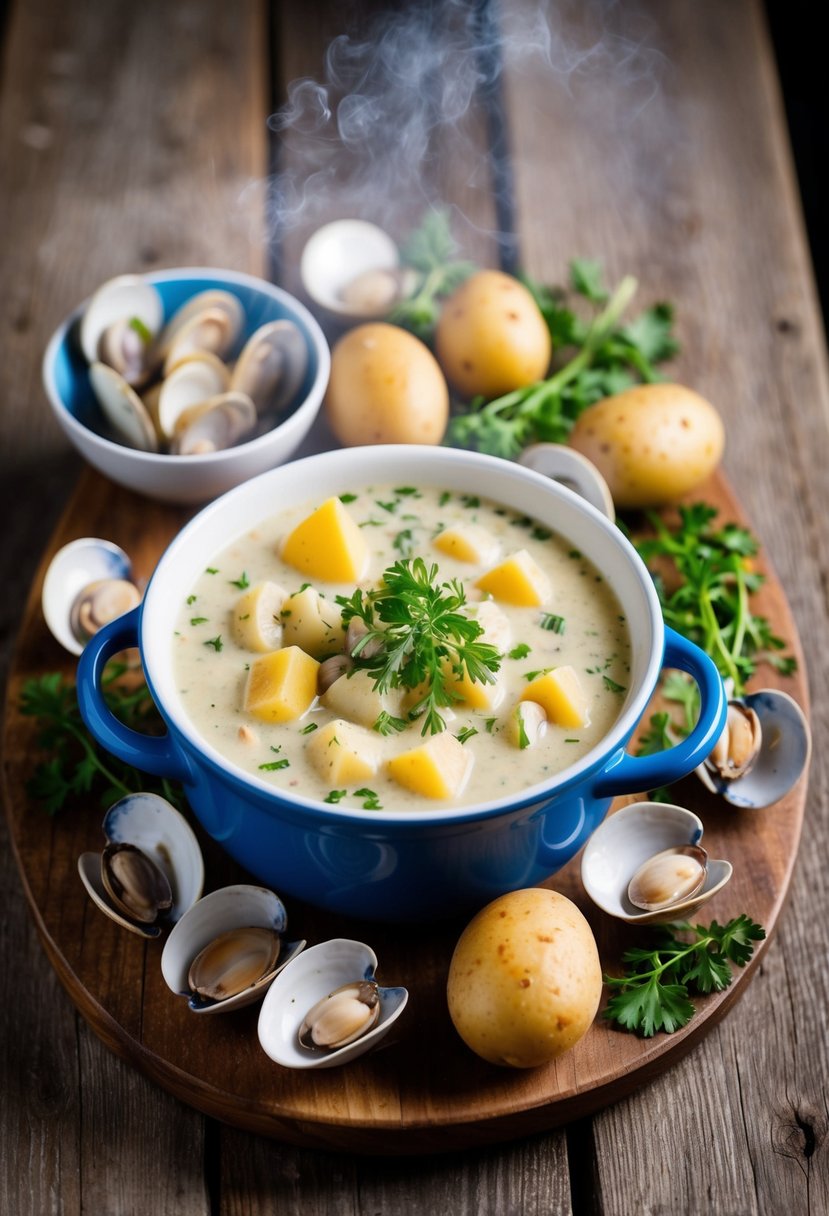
<box><xmin>43</xmin><ymin>268</ymin><xmax>331</xmax><ymax>503</ymax></box>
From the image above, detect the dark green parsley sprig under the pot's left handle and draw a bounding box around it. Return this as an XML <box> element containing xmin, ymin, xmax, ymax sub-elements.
<box><xmin>19</xmin><ymin>663</ymin><xmax>184</xmax><ymax>815</ymax></box>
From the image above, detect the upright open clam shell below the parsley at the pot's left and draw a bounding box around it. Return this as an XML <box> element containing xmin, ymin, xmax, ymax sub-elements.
<box><xmin>78</xmin><ymin>793</ymin><xmax>204</xmax><ymax>938</ymax></box>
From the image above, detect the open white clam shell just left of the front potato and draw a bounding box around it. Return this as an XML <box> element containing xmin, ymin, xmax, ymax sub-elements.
<box><xmin>259</xmin><ymin>938</ymin><xmax>408</xmax><ymax>1069</ymax></box>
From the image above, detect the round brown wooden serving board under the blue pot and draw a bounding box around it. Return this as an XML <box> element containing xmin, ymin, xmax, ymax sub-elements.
<box><xmin>4</xmin><ymin>471</ymin><xmax>808</xmax><ymax>1154</ymax></box>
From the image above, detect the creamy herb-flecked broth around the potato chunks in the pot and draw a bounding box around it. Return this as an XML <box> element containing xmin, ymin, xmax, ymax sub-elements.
<box><xmin>174</xmin><ymin>486</ymin><xmax>630</xmax><ymax>811</ymax></box>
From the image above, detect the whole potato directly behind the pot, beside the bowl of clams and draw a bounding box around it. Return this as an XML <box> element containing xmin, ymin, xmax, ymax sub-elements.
<box><xmin>325</xmin><ymin>322</ymin><xmax>449</xmax><ymax>447</ymax></box>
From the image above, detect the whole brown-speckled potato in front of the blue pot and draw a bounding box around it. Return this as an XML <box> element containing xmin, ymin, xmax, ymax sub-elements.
<box><xmin>446</xmin><ymin>888</ymin><xmax>602</xmax><ymax>1068</ymax></box>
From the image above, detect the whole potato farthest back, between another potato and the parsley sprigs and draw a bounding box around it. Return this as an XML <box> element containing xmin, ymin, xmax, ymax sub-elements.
<box><xmin>435</xmin><ymin>270</ymin><xmax>552</xmax><ymax>398</ymax></box>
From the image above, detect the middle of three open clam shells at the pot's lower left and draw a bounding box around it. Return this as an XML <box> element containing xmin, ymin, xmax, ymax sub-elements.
<box><xmin>162</xmin><ymin>883</ymin><xmax>305</xmax><ymax>1013</ymax></box>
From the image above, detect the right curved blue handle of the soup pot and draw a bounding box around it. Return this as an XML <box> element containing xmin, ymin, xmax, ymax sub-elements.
<box><xmin>593</xmin><ymin>626</ymin><xmax>728</xmax><ymax>798</ymax></box>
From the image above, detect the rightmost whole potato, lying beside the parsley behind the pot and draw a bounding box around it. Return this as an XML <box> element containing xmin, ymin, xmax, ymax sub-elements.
<box><xmin>570</xmin><ymin>384</ymin><xmax>726</xmax><ymax>508</ymax></box>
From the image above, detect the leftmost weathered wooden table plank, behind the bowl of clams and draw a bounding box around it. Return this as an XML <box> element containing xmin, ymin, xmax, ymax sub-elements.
<box><xmin>0</xmin><ymin>0</ymin><xmax>269</xmax><ymax>1216</ymax></box>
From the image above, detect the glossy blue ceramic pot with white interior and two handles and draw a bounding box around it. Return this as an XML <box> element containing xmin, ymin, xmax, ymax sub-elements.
<box><xmin>78</xmin><ymin>446</ymin><xmax>726</xmax><ymax>922</ymax></box>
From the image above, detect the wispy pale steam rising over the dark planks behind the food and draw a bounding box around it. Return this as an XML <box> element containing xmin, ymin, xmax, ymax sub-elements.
<box><xmin>269</xmin><ymin>0</ymin><xmax>664</xmax><ymax>256</ymax></box>
